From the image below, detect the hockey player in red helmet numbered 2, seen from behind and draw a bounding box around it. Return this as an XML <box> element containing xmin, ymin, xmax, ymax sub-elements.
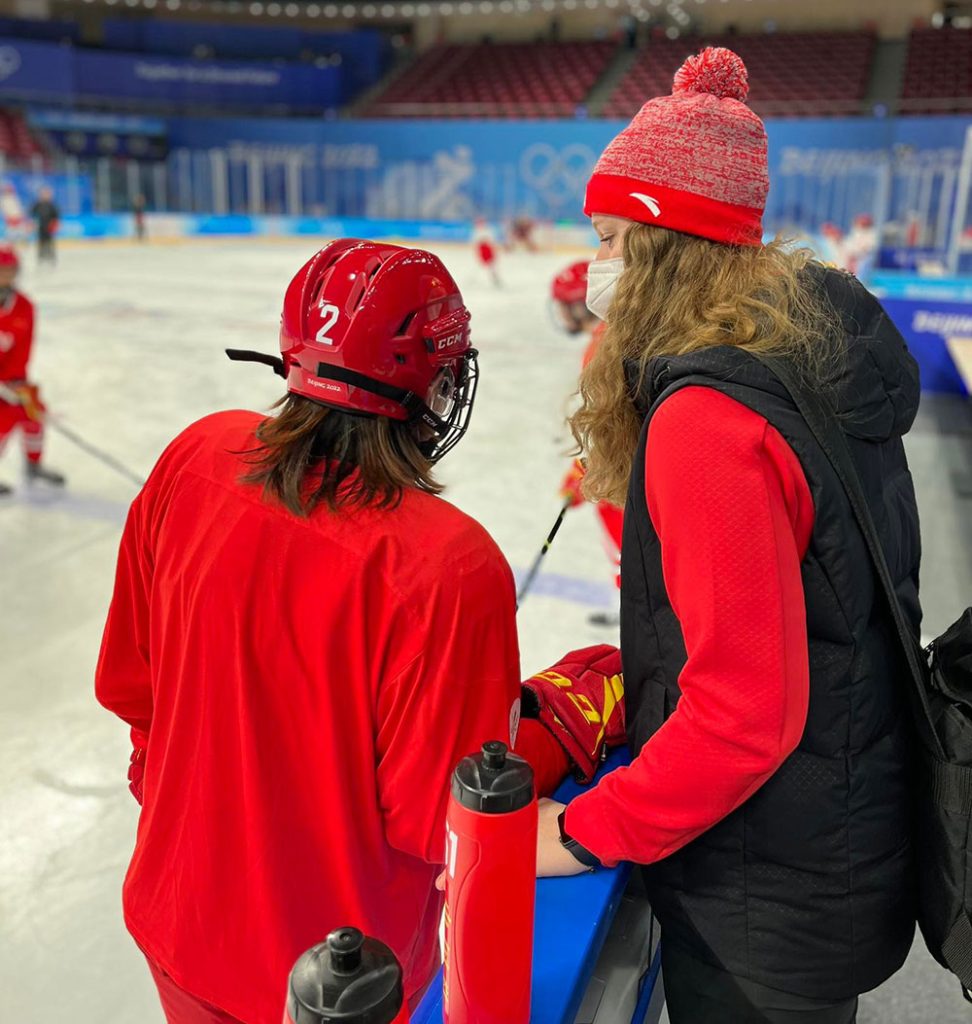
<box><xmin>96</xmin><ymin>239</ymin><xmax>603</xmax><ymax>1024</ymax></box>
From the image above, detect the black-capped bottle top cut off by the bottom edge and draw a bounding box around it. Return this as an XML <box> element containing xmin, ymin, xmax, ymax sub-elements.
<box><xmin>284</xmin><ymin>928</ymin><xmax>409</xmax><ymax>1024</ymax></box>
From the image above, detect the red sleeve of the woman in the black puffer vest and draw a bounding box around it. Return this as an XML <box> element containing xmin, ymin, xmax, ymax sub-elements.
<box><xmin>565</xmin><ymin>387</ymin><xmax>813</xmax><ymax>864</ymax></box>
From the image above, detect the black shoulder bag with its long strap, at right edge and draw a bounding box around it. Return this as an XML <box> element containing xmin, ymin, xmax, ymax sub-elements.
<box><xmin>759</xmin><ymin>356</ymin><xmax>972</xmax><ymax>1001</ymax></box>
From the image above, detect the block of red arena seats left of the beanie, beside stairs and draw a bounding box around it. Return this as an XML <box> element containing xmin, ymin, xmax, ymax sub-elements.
<box><xmin>365</xmin><ymin>42</ymin><xmax>617</xmax><ymax>118</ymax></box>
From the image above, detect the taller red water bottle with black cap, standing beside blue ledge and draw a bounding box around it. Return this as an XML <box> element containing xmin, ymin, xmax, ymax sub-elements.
<box><xmin>442</xmin><ymin>740</ymin><xmax>537</xmax><ymax>1024</ymax></box>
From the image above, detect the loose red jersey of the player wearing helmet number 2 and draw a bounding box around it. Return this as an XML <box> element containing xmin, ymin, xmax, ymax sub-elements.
<box><xmin>96</xmin><ymin>412</ymin><xmax>519</xmax><ymax>1024</ymax></box>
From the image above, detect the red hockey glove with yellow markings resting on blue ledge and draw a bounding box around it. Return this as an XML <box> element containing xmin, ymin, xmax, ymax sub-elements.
<box><xmin>520</xmin><ymin>644</ymin><xmax>625</xmax><ymax>782</ymax></box>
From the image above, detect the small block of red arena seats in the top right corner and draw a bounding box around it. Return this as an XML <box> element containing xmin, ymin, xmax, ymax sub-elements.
<box><xmin>901</xmin><ymin>28</ymin><xmax>972</xmax><ymax>114</ymax></box>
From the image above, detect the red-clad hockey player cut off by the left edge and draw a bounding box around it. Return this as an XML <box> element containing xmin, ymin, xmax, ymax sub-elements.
<box><xmin>0</xmin><ymin>245</ymin><xmax>65</xmax><ymax>497</ymax></box>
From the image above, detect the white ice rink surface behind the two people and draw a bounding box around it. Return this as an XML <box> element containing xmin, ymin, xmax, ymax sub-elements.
<box><xmin>0</xmin><ymin>240</ymin><xmax>616</xmax><ymax>1024</ymax></box>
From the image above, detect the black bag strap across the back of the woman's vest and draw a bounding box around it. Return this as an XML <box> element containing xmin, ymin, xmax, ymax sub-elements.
<box><xmin>756</xmin><ymin>355</ymin><xmax>945</xmax><ymax>761</ymax></box>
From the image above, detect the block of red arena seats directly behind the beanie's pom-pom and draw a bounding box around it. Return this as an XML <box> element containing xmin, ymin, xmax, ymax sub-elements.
<box><xmin>603</xmin><ymin>32</ymin><xmax>875</xmax><ymax>118</ymax></box>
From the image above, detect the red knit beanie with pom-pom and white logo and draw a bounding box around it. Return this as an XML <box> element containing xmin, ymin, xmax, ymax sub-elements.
<box><xmin>584</xmin><ymin>46</ymin><xmax>769</xmax><ymax>246</ymax></box>
